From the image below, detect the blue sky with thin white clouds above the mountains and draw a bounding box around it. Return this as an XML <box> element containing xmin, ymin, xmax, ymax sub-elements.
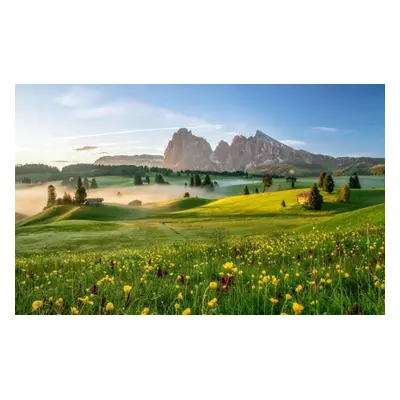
<box><xmin>15</xmin><ymin>85</ymin><xmax>385</xmax><ymax>167</ymax></box>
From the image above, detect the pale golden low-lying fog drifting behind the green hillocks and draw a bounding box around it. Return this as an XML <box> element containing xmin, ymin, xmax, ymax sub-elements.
<box><xmin>15</xmin><ymin>183</ymin><xmax>216</xmax><ymax>216</ymax></box>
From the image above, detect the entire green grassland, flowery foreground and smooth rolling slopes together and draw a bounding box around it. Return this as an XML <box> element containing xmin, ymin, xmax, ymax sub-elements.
<box><xmin>15</xmin><ymin>182</ymin><xmax>385</xmax><ymax>315</ymax></box>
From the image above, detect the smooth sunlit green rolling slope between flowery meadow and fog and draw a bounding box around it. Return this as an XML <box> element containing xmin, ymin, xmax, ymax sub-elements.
<box><xmin>16</xmin><ymin>189</ymin><xmax>385</xmax><ymax>254</ymax></box>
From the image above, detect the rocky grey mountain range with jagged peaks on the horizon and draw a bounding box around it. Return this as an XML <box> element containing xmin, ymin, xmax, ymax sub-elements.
<box><xmin>95</xmin><ymin>128</ymin><xmax>385</xmax><ymax>175</ymax></box>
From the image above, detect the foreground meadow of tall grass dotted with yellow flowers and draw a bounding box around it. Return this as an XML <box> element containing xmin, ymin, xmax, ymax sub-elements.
<box><xmin>15</xmin><ymin>226</ymin><xmax>385</xmax><ymax>315</ymax></box>
